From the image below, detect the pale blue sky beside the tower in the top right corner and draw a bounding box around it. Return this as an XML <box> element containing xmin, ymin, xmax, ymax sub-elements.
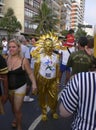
<box><xmin>85</xmin><ymin>0</ymin><xmax>96</xmax><ymax>25</ymax></box>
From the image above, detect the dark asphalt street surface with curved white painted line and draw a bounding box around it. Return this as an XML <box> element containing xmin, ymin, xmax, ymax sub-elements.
<box><xmin>0</xmin><ymin>73</ymin><xmax>73</xmax><ymax>130</ymax></box>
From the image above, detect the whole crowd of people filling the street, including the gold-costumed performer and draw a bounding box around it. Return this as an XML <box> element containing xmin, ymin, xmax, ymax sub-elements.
<box><xmin>0</xmin><ymin>29</ymin><xmax>96</xmax><ymax>130</ymax></box>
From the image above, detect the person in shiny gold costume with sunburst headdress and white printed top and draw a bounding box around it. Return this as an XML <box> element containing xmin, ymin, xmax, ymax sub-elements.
<box><xmin>31</xmin><ymin>34</ymin><xmax>59</xmax><ymax>121</ymax></box>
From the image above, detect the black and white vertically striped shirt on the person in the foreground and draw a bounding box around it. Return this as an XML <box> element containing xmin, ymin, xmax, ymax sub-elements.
<box><xmin>60</xmin><ymin>72</ymin><xmax>96</xmax><ymax>130</ymax></box>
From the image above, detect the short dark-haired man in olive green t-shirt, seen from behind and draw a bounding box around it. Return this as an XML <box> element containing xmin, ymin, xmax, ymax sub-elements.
<box><xmin>67</xmin><ymin>36</ymin><xmax>92</xmax><ymax>75</ymax></box>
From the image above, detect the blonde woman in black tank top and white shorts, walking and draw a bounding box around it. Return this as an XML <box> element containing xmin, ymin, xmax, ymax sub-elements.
<box><xmin>7</xmin><ymin>39</ymin><xmax>37</xmax><ymax>130</ymax></box>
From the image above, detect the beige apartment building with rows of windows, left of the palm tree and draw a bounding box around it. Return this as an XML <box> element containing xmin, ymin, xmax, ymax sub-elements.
<box><xmin>4</xmin><ymin>0</ymin><xmax>41</xmax><ymax>35</ymax></box>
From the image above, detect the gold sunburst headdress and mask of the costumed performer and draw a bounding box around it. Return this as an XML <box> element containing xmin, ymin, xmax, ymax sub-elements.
<box><xmin>30</xmin><ymin>32</ymin><xmax>61</xmax><ymax>55</ymax></box>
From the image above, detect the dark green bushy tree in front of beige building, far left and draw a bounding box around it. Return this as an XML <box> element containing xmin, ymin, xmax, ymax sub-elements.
<box><xmin>0</xmin><ymin>8</ymin><xmax>22</xmax><ymax>37</ymax></box>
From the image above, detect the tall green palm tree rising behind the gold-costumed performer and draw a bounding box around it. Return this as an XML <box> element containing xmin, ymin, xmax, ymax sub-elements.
<box><xmin>32</xmin><ymin>0</ymin><xmax>59</xmax><ymax>34</ymax></box>
